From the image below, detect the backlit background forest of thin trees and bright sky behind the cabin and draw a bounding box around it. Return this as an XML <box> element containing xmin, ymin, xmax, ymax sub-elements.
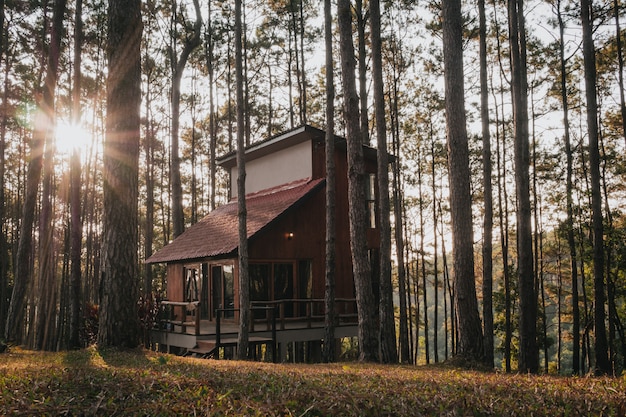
<box><xmin>0</xmin><ymin>0</ymin><xmax>626</xmax><ymax>374</ymax></box>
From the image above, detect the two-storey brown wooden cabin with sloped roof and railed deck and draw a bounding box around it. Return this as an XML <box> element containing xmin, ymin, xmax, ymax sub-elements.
<box><xmin>146</xmin><ymin>125</ymin><xmax>379</xmax><ymax>361</ymax></box>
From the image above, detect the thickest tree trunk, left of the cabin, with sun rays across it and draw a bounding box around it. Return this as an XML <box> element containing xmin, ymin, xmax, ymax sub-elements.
<box><xmin>98</xmin><ymin>0</ymin><xmax>143</xmax><ymax>348</ymax></box>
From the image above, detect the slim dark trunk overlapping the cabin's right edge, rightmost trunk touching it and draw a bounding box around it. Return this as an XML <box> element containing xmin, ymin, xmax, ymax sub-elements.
<box><xmin>370</xmin><ymin>0</ymin><xmax>398</xmax><ymax>363</ymax></box>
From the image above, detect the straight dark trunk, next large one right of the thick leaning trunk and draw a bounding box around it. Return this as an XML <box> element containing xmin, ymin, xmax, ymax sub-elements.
<box><xmin>509</xmin><ymin>0</ymin><xmax>539</xmax><ymax>373</ymax></box>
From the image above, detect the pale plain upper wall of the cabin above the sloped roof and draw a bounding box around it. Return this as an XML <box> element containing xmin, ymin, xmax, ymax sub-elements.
<box><xmin>230</xmin><ymin>140</ymin><xmax>313</xmax><ymax>197</ymax></box>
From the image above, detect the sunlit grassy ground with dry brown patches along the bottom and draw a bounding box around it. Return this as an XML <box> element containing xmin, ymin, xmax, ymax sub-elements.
<box><xmin>0</xmin><ymin>347</ymin><xmax>626</xmax><ymax>416</ymax></box>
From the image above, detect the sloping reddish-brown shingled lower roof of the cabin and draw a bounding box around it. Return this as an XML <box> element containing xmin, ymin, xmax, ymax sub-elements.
<box><xmin>146</xmin><ymin>179</ymin><xmax>324</xmax><ymax>263</ymax></box>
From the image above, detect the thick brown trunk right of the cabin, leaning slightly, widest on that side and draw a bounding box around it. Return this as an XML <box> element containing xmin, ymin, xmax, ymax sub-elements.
<box><xmin>443</xmin><ymin>0</ymin><xmax>484</xmax><ymax>361</ymax></box>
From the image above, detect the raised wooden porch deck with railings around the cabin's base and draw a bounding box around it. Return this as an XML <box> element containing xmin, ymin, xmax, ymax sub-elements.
<box><xmin>151</xmin><ymin>298</ymin><xmax>357</xmax><ymax>362</ymax></box>
